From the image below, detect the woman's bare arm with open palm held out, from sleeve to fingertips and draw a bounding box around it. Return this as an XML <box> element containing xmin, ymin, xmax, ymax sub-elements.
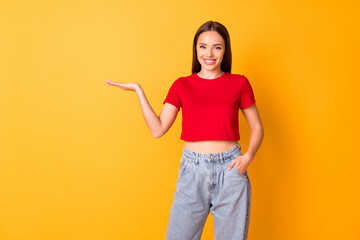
<box><xmin>106</xmin><ymin>80</ymin><xmax>178</xmax><ymax>138</ymax></box>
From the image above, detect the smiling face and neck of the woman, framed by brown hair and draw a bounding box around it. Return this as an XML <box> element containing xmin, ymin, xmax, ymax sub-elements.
<box><xmin>196</xmin><ymin>31</ymin><xmax>225</xmax><ymax>72</ymax></box>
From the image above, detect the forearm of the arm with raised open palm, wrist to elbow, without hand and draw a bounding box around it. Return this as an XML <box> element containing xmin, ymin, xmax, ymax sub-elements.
<box><xmin>136</xmin><ymin>87</ymin><xmax>161</xmax><ymax>138</ymax></box>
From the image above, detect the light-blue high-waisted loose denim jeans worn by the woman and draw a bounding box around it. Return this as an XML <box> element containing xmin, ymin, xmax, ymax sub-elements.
<box><xmin>166</xmin><ymin>143</ymin><xmax>251</xmax><ymax>240</ymax></box>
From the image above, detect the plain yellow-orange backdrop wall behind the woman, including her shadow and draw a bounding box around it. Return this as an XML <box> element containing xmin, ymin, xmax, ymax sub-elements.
<box><xmin>0</xmin><ymin>0</ymin><xmax>360</xmax><ymax>240</ymax></box>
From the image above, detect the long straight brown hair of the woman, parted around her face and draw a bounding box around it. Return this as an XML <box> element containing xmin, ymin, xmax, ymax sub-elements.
<box><xmin>191</xmin><ymin>21</ymin><xmax>231</xmax><ymax>73</ymax></box>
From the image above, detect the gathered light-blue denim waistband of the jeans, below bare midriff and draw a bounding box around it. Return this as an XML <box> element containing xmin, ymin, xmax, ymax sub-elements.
<box><xmin>183</xmin><ymin>142</ymin><xmax>241</xmax><ymax>164</ymax></box>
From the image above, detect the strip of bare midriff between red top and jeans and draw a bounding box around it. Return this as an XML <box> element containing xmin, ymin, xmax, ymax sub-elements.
<box><xmin>184</xmin><ymin>140</ymin><xmax>237</xmax><ymax>154</ymax></box>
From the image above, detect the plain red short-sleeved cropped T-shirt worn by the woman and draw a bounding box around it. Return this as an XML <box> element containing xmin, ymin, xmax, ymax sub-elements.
<box><xmin>163</xmin><ymin>72</ymin><xmax>255</xmax><ymax>141</ymax></box>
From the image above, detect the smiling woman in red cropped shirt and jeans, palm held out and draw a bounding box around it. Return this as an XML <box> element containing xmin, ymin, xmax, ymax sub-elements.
<box><xmin>107</xmin><ymin>21</ymin><xmax>264</xmax><ymax>240</ymax></box>
